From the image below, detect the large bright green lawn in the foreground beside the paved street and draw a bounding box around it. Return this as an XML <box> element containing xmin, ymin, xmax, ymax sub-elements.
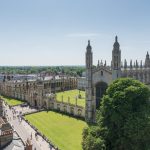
<box><xmin>25</xmin><ymin>111</ymin><xmax>87</xmax><ymax>150</ymax></box>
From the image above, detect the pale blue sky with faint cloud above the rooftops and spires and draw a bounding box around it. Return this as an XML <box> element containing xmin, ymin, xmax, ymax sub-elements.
<box><xmin>0</xmin><ymin>0</ymin><xmax>150</xmax><ymax>66</ymax></box>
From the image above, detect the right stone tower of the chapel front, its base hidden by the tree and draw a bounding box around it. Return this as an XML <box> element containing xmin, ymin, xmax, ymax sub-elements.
<box><xmin>112</xmin><ymin>36</ymin><xmax>121</xmax><ymax>80</ymax></box>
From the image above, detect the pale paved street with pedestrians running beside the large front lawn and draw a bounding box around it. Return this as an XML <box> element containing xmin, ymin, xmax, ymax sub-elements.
<box><xmin>5</xmin><ymin>106</ymin><xmax>54</xmax><ymax>150</ymax></box>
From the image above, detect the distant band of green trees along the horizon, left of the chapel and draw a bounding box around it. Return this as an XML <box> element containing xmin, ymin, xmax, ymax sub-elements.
<box><xmin>0</xmin><ymin>66</ymin><xmax>85</xmax><ymax>76</ymax></box>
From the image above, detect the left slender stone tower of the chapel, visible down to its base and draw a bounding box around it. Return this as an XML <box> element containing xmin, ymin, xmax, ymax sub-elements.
<box><xmin>85</xmin><ymin>41</ymin><xmax>95</xmax><ymax>122</ymax></box>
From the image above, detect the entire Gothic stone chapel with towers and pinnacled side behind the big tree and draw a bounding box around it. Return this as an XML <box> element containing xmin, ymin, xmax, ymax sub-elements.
<box><xmin>85</xmin><ymin>36</ymin><xmax>150</xmax><ymax>122</ymax></box>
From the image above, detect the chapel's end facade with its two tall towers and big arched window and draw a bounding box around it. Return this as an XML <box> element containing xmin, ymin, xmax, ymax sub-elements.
<box><xmin>85</xmin><ymin>36</ymin><xmax>121</xmax><ymax>122</ymax></box>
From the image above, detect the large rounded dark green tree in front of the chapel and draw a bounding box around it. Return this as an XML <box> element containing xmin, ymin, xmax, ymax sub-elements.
<box><xmin>83</xmin><ymin>78</ymin><xmax>150</xmax><ymax>150</ymax></box>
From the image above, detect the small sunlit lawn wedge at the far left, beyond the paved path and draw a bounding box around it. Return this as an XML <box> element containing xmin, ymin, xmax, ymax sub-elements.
<box><xmin>1</xmin><ymin>96</ymin><xmax>24</xmax><ymax>106</ymax></box>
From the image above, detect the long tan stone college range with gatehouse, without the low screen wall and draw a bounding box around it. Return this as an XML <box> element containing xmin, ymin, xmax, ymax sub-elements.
<box><xmin>0</xmin><ymin>76</ymin><xmax>77</xmax><ymax>108</ymax></box>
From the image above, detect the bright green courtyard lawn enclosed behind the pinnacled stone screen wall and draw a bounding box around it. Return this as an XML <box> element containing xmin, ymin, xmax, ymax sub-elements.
<box><xmin>56</xmin><ymin>90</ymin><xmax>85</xmax><ymax>107</ymax></box>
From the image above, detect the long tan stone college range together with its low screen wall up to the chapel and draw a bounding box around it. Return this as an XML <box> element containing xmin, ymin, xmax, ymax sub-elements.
<box><xmin>0</xmin><ymin>76</ymin><xmax>85</xmax><ymax>117</ymax></box>
